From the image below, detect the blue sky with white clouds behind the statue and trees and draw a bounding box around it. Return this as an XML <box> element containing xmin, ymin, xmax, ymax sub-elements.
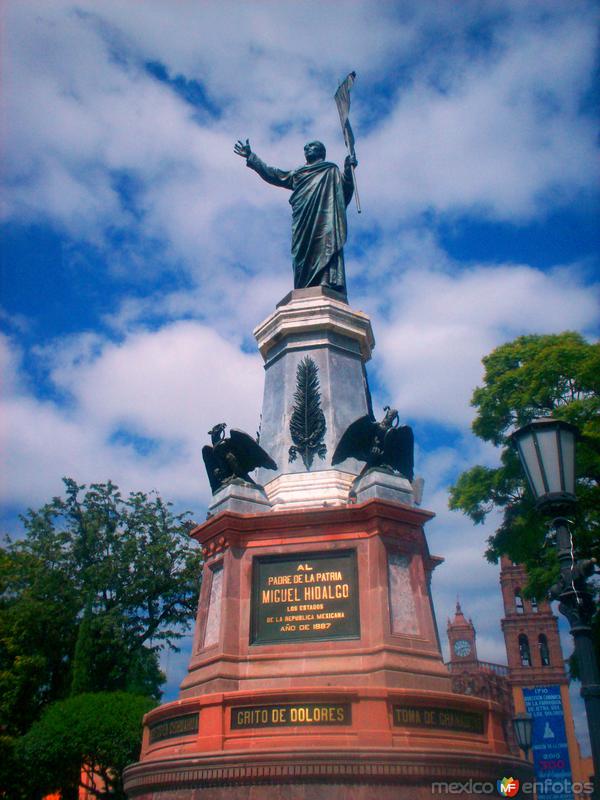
<box><xmin>0</xmin><ymin>0</ymin><xmax>600</xmax><ymax>752</ymax></box>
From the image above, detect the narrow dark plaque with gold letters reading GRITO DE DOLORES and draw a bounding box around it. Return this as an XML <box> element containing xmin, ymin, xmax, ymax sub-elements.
<box><xmin>231</xmin><ymin>703</ymin><xmax>352</xmax><ymax>730</ymax></box>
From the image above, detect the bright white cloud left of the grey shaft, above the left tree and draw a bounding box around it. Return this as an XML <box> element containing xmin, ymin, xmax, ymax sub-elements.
<box><xmin>2</xmin><ymin>322</ymin><xmax>262</xmax><ymax>510</ymax></box>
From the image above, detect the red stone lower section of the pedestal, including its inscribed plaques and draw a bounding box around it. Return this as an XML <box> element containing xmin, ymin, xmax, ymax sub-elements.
<box><xmin>125</xmin><ymin>498</ymin><xmax>529</xmax><ymax>800</ymax></box>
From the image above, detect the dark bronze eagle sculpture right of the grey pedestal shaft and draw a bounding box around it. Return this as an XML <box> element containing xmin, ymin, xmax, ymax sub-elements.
<box><xmin>331</xmin><ymin>406</ymin><xmax>414</xmax><ymax>481</ymax></box>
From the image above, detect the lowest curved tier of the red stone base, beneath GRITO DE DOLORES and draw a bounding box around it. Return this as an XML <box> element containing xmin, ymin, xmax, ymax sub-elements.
<box><xmin>127</xmin><ymin>750</ymin><xmax>533</xmax><ymax>800</ymax></box>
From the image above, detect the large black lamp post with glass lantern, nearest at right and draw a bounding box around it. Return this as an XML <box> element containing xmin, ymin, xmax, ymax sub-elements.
<box><xmin>511</xmin><ymin>418</ymin><xmax>600</xmax><ymax>800</ymax></box>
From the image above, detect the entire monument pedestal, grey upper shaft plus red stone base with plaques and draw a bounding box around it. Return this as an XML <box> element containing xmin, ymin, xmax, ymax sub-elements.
<box><xmin>125</xmin><ymin>288</ymin><xmax>532</xmax><ymax>800</ymax></box>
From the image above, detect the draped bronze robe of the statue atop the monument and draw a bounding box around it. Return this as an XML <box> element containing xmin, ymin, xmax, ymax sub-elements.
<box><xmin>246</xmin><ymin>153</ymin><xmax>354</xmax><ymax>294</ymax></box>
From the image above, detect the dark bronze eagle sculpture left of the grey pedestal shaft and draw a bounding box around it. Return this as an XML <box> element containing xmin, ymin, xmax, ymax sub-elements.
<box><xmin>202</xmin><ymin>422</ymin><xmax>277</xmax><ymax>494</ymax></box>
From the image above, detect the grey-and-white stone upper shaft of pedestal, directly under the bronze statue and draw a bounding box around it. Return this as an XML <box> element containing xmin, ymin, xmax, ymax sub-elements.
<box><xmin>254</xmin><ymin>287</ymin><xmax>375</xmax><ymax>509</ymax></box>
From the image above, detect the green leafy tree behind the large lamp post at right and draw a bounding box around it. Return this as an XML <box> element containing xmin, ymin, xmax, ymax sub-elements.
<box><xmin>450</xmin><ymin>332</ymin><xmax>600</xmax><ymax>664</ymax></box>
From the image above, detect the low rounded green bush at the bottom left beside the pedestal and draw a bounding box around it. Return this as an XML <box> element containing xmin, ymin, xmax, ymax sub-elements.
<box><xmin>16</xmin><ymin>692</ymin><xmax>155</xmax><ymax>800</ymax></box>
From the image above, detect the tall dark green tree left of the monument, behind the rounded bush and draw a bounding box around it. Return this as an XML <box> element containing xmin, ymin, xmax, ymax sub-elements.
<box><xmin>0</xmin><ymin>479</ymin><xmax>201</xmax><ymax>736</ymax></box>
